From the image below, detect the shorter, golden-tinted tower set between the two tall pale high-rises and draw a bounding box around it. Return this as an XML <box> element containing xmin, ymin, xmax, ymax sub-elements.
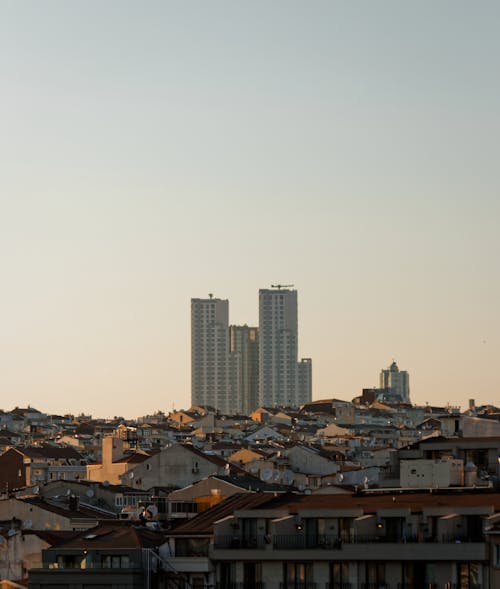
<box><xmin>229</xmin><ymin>325</ymin><xmax>259</xmax><ymax>415</ymax></box>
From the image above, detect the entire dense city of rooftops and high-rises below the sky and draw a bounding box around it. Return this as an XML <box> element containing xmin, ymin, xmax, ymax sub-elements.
<box><xmin>0</xmin><ymin>285</ymin><xmax>500</xmax><ymax>589</ymax></box>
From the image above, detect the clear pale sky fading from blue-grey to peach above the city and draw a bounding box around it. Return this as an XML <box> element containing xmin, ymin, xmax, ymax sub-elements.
<box><xmin>0</xmin><ymin>0</ymin><xmax>500</xmax><ymax>417</ymax></box>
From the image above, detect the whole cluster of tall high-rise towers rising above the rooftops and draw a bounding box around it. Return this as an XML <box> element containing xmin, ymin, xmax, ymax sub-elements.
<box><xmin>191</xmin><ymin>287</ymin><xmax>312</xmax><ymax>414</ymax></box>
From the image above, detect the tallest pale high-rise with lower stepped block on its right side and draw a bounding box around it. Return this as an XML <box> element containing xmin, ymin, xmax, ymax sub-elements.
<box><xmin>259</xmin><ymin>287</ymin><xmax>312</xmax><ymax>407</ymax></box>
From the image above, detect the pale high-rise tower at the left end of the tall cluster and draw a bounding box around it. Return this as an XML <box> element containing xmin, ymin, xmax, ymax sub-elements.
<box><xmin>191</xmin><ymin>295</ymin><xmax>231</xmax><ymax>413</ymax></box>
